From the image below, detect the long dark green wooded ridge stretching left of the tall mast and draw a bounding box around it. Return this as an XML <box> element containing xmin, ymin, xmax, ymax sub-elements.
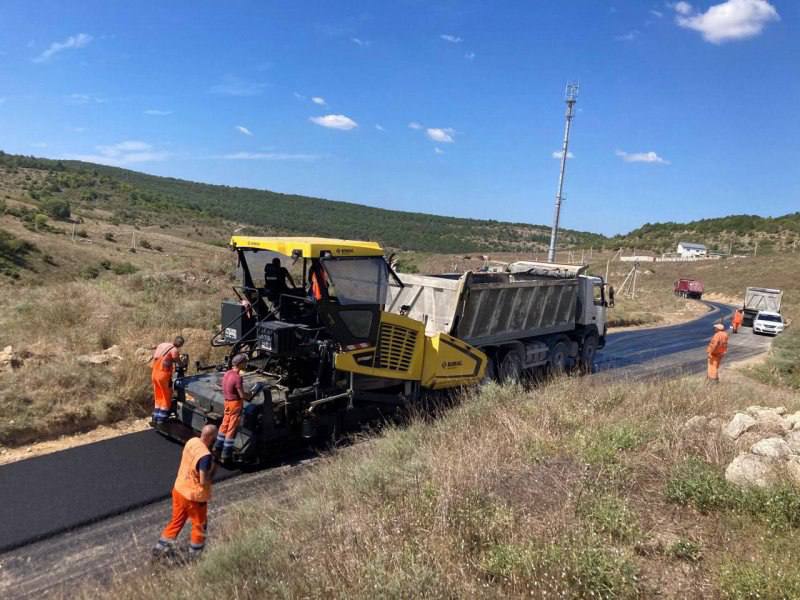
<box><xmin>0</xmin><ymin>152</ymin><xmax>605</xmax><ymax>253</ymax></box>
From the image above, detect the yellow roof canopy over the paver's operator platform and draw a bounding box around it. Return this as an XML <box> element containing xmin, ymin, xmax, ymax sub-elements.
<box><xmin>230</xmin><ymin>235</ymin><xmax>383</xmax><ymax>258</ymax></box>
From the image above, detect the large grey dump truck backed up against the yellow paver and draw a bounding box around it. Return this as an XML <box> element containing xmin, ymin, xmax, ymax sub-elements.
<box><xmin>387</xmin><ymin>261</ymin><xmax>607</xmax><ymax>381</ymax></box>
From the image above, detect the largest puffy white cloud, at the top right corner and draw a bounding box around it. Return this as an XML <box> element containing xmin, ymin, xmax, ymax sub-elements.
<box><xmin>673</xmin><ymin>0</ymin><xmax>780</xmax><ymax>44</ymax></box>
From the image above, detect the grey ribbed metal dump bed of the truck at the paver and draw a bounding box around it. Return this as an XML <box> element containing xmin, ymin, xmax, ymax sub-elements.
<box><xmin>386</xmin><ymin>263</ymin><xmax>578</xmax><ymax>346</ymax></box>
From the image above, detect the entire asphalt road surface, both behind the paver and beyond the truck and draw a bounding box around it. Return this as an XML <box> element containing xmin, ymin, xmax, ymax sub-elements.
<box><xmin>0</xmin><ymin>303</ymin><xmax>770</xmax><ymax>598</ymax></box>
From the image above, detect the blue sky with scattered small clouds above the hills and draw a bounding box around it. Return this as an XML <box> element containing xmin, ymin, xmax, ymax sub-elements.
<box><xmin>0</xmin><ymin>0</ymin><xmax>800</xmax><ymax>236</ymax></box>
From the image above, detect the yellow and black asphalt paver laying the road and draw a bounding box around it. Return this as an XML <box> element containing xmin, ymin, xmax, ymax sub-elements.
<box><xmin>154</xmin><ymin>236</ymin><xmax>488</xmax><ymax>464</ymax></box>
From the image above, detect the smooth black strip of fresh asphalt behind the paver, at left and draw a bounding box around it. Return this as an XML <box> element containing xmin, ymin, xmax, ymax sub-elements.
<box><xmin>0</xmin><ymin>430</ymin><xmax>235</xmax><ymax>552</ymax></box>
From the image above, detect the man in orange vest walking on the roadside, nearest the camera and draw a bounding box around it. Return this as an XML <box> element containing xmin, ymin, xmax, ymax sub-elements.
<box><xmin>153</xmin><ymin>425</ymin><xmax>217</xmax><ymax>558</ymax></box>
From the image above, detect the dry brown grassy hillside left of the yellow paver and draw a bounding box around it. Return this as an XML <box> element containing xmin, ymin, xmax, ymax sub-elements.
<box><xmin>0</xmin><ymin>169</ymin><xmax>232</xmax><ymax>446</ymax></box>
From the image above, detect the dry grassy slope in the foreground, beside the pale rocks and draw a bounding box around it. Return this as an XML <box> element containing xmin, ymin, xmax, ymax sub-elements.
<box><xmin>87</xmin><ymin>378</ymin><xmax>800</xmax><ymax>599</ymax></box>
